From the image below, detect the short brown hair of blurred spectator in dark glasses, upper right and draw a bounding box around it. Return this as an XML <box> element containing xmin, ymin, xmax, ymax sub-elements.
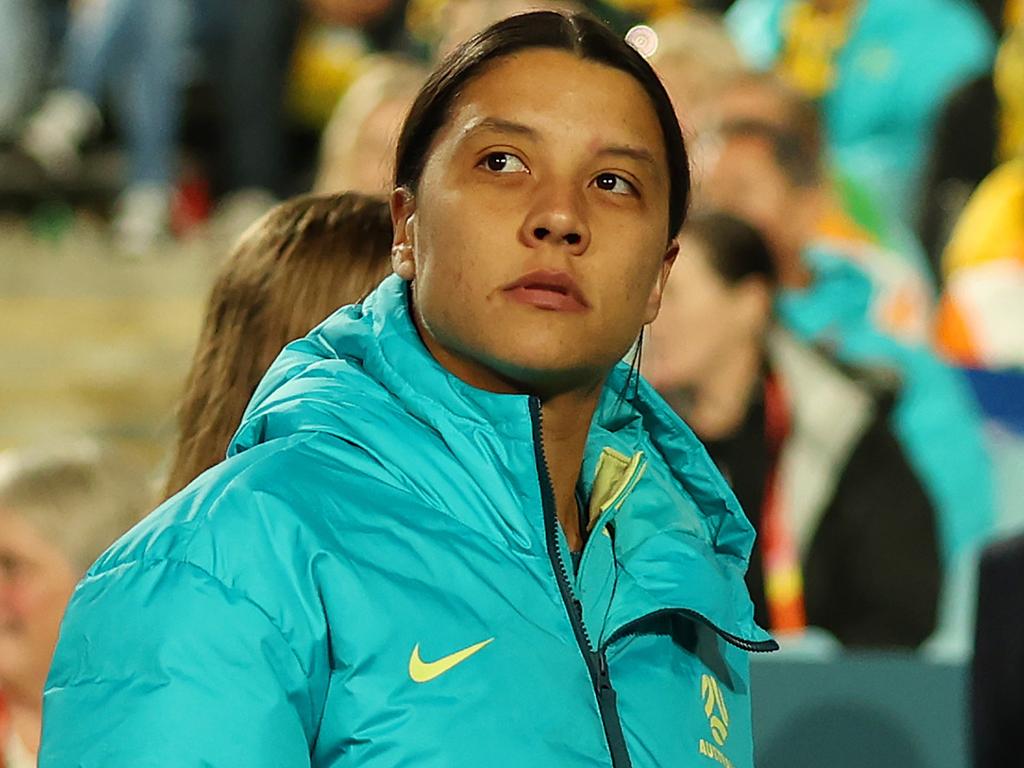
<box><xmin>719</xmin><ymin>72</ymin><xmax>824</xmax><ymax>186</ymax></box>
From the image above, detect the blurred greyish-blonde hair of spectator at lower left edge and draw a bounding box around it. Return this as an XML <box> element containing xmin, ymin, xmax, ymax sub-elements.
<box><xmin>0</xmin><ymin>438</ymin><xmax>151</xmax><ymax>573</ymax></box>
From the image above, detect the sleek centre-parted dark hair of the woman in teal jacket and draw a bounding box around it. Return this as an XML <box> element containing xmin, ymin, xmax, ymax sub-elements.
<box><xmin>394</xmin><ymin>11</ymin><xmax>690</xmax><ymax>239</ymax></box>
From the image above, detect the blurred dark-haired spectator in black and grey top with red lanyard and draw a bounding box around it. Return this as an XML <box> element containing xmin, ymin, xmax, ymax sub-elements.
<box><xmin>644</xmin><ymin>213</ymin><xmax>941</xmax><ymax>647</ymax></box>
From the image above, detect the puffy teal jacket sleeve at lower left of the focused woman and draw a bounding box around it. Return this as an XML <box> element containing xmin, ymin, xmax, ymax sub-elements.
<box><xmin>39</xmin><ymin>560</ymin><xmax>315</xmax><ymax>768</ymax></box>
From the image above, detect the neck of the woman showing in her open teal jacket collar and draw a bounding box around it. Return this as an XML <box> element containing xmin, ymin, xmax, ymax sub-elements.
<box><xmin>542</xmin><ymin>386</ymin><xmax>601</xmax><ymax>552</ymax></box>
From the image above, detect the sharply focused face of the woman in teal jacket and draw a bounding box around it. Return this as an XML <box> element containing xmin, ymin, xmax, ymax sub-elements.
<box><xmin>394</xmin><ymin>49</ymin><xmax>675</xmax><ymax>393</ymax></box>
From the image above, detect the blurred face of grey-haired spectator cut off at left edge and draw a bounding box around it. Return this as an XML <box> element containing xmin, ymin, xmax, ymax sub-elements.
<box><xmin>0</xmin><ymin>510</ymin><xmax>77</xmax><ymax>696</ymax></box>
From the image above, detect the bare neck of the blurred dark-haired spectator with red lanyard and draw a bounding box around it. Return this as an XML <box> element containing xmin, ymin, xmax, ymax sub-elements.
<box><xmin>686</xmin><ymin>340</ymin><xmax>763</xmax><ymax>440</ymax></box>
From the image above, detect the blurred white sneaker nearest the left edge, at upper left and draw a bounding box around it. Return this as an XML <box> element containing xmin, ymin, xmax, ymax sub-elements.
<box><xmin>18</xmin><ymin>90</ymin><xmax>102</xmax><ymax>178</ymax></box>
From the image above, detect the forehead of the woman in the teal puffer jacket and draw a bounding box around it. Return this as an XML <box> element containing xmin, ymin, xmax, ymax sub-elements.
<box><xmin>446</xmin><ymin>48</ymin><xmax>666</xmax><ymax>157</ymax></box>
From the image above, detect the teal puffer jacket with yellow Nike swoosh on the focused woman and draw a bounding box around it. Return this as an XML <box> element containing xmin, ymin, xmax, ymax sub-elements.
<box><xmin>40</xmin><ymin>278</ymin><xmax>775</xmax><ymax>768</ymax></box>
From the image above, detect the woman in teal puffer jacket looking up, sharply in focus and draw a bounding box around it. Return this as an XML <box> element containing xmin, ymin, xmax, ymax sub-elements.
<box><xmin>40</xmin><ymin>12</ymin><xmax>775</xmax><ymax>768</ymax></box>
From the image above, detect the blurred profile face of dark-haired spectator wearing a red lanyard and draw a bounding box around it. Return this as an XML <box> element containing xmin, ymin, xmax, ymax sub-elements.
<box><xmin>643</xmin><ymin>234</ymin><xmax>755</xmax><ymax>394</ymax></box>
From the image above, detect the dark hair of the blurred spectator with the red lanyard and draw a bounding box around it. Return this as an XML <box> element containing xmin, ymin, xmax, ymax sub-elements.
<box><xmin>683</xmin><ymin>211</ymin><xmax>778</xmax><ymax>286</ymax></box>
